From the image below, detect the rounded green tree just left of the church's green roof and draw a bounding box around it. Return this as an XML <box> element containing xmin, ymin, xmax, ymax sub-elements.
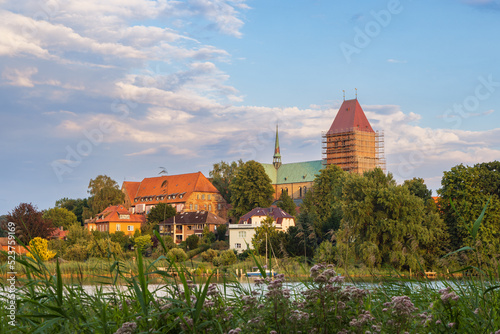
<box><xmin>229</xmin><ymin>160</ymin><xmax>274</xmax><ymax>219</ymax></box>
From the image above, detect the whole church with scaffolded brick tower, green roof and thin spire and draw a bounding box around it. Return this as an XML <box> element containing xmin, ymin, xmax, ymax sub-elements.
<box><xmin>261</xmin><ymin>97</ymin><xmax>384</xmax><ymax>203</ymax></box>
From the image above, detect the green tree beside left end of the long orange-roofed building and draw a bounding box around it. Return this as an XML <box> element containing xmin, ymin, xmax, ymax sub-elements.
<box><xmin>88</xmin><ymin>175</ymin><xmax>125</xmax><ymax>215</ymax></box>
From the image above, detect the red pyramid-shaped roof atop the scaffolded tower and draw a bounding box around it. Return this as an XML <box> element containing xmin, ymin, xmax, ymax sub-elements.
<box><xmin>328</xmin><ymin>99</ymin><xmax>375</xmax><ymax>133</ymax></box>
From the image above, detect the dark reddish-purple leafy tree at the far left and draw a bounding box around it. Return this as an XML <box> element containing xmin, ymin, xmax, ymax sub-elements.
<box><xmin>7</xmin><ymin>203</ymin><xmax>55</xmax><ymax>244</ymax></box>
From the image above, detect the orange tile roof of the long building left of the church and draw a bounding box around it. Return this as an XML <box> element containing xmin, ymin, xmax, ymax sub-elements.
<box><xmin>122</xmin><ymin>172</ymin><xmax>219</xmax><ymax>205</ymax></box>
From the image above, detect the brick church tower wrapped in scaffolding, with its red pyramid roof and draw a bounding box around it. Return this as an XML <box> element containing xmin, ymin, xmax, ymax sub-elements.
<box><xmin>323</xmin><ymin>98</ymin><xmax>385</xmax><ymax>174</ymax></box>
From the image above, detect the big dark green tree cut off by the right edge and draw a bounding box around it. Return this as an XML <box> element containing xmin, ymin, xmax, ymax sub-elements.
<box><xmin>438</xmin><ymin>161</ymin><xmax>500</xmax><ymax>260</ymax></box>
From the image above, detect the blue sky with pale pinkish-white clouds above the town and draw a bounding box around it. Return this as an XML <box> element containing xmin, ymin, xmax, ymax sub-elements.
<box><xmin>0</xmin><ymin>0</ymin><xmax>500</xmax><ymax>214</ymax></box>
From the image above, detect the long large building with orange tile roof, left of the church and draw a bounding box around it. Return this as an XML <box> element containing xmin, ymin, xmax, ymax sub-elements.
<box><xmin>122</xmin><ymin>172</ymin><xmax>227</xmax><ymax>219</ymax></box>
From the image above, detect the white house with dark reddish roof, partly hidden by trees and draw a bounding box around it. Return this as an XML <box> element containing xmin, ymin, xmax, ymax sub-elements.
<box><xmin>229</xmin><ymin>206</ymin><xmax>295</xmax><ymax>253</ymax></box>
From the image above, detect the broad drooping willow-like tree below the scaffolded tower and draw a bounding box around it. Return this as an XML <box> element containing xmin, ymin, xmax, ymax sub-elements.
<box><xmin>337</xmin><ymin>168</ymin><xmax>446</xmax><ymax>270</ymax></box>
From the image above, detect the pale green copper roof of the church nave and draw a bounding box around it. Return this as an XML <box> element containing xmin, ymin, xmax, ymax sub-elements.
<box><xmin>261</xmin><ymin>160</ymin><xmax>324</xmax><ymax>184</ymax></box>
